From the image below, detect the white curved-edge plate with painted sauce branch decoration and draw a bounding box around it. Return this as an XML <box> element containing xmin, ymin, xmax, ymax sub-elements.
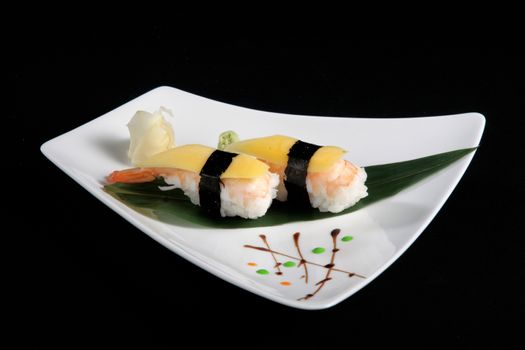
<box><xmin>41</xmin><ymin>87</ymin><xmax>485</xmax><ymax>309</ymax></box>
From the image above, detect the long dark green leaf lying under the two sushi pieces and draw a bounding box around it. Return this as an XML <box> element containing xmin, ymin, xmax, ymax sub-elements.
<box><xmin>104</xmin><ymin>148</ymin><xmax>476</xmax><ymax>228</ymax></box>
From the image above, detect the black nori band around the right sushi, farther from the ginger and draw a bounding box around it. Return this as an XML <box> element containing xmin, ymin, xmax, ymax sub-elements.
<box><xmin>284</xmin><ymin>140</ymin><xmax>322</xmax><ymax>208</ymax></box>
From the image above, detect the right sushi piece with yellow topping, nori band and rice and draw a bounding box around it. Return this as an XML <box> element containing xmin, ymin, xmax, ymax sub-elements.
<box><xmin>225</xmin><ymin>135</ymin><xmax>368</xmax><ymax>213</ymax></box>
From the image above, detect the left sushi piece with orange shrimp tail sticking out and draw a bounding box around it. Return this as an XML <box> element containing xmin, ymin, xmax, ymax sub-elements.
<box><xmin>107</xmin><ymin>145</ymin><xmax>279</xmax><ymax>219</ymax></box>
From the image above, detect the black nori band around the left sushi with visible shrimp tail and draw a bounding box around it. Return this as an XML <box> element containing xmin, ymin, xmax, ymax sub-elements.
<box><xmin>199</xmin><ymin>150</ymin><xmax>237</xmax><ymax>216</ymax></box>
